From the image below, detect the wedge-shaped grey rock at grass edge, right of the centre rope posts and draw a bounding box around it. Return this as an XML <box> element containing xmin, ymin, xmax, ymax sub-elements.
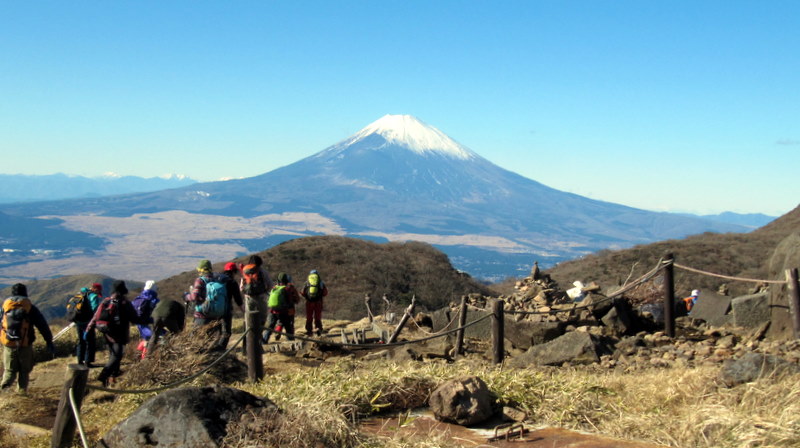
<box><xmin>510</xmin><ymin>331</ymin><xmax>600</xmax><ymax>367</ymax></box>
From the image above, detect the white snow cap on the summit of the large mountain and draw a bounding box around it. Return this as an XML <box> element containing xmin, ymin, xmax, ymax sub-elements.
<box><xmin>341</xmin><ymin>115</ymin><xmax>477</xmax><ymax>159</ymax></box>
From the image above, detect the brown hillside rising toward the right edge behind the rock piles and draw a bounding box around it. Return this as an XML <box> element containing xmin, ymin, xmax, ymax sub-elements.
<box><xmin>547</xmin><ymin>206</ymin><xmax>800</xmax><ymax>295</ymax></box>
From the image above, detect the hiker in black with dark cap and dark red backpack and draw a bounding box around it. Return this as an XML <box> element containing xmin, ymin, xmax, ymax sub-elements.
<box><xmin>86</xmin><ymin>280</ymin><xmax>141</xmax><ymax>386</ymax></box>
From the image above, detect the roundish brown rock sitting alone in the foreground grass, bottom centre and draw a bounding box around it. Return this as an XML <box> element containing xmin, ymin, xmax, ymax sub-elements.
<box><xmin>428</xmin><ymin>376</ymin><xmax>496</xmax><ymax>426</ymax></box>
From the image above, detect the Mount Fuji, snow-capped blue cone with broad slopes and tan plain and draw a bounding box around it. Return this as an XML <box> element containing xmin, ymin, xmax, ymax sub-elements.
<box><xmin>0</xmin><ymin>115</ymin><xmax>748</xmax><ymax>279</ymax></box>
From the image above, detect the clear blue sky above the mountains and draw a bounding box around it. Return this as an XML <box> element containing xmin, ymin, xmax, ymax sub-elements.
<box><xmin>0</xmin><ymin>0</ymin><xmax>800</xmax><ymax>215</ymax></box>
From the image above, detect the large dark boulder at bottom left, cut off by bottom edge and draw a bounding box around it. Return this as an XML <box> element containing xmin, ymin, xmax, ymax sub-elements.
<box><xmin>100</xmin><ymin>387</ymin><xmax>277</xmax><ymax>448</ymax></box>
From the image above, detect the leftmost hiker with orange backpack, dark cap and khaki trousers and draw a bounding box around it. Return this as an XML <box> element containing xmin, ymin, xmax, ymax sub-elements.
<box><xmin>0</xmin><ymin>283</ymin><xmax>55</xmax><ymax>394</ymax></box>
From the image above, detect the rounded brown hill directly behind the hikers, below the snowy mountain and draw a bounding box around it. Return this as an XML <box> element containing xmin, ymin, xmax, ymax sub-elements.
<box><xmin>152</xmin><ymin>236</ymin><xmax>488</xmax><ymax>319</ymax></box>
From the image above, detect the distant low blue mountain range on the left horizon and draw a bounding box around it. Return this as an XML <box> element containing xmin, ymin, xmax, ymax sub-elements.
<box><xmin>0</xmin><ymin>173</ymin><xmax>197</xmax><ymax>203</ymax></box>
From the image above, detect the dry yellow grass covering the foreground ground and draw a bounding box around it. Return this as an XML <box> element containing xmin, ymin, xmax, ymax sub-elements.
<box><xmin>12</xmin><ymin>326</ymin><xmax>800</xmax><ymax>448</ymax></box>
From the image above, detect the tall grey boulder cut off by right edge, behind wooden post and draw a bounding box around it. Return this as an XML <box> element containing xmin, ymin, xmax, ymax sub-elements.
<box><xmin>768</xmin><ymin>233</ymin><xmax>800</xmax><ymax>339</ymax></box>
